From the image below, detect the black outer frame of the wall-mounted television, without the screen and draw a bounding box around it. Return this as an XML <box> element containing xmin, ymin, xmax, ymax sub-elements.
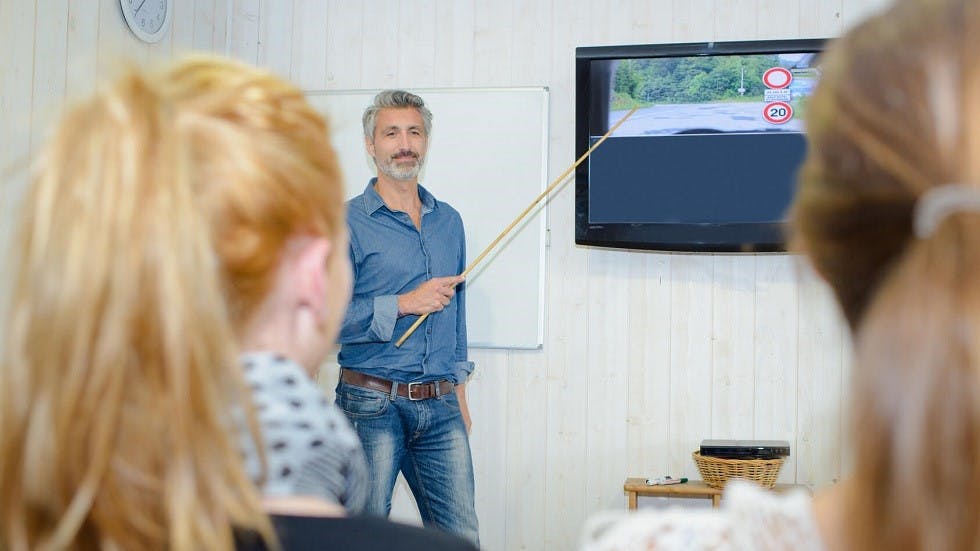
<box><xmin>575</xmin><ymin>38</ymin><xmax>828</xmax><ymax>253</ymax></box>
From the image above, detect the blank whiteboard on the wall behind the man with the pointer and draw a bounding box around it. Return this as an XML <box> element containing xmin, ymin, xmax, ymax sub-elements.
<box><xmin>306</xmin><ymin>88</ymin><xmax>548</xmax><ymax>348</ymax></box>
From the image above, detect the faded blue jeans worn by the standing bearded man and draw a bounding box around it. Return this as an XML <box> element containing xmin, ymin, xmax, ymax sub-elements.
<box><xmin>336</xmin><ymin>381</ymin><xmax>479</xmax><ymax>545</ymax></box>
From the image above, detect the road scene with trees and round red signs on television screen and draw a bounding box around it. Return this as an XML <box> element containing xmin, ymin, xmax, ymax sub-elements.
<box><xmin>608</xmin><ymin>52</ymin><xmax>820</xmax><ymax>137</ymax></box>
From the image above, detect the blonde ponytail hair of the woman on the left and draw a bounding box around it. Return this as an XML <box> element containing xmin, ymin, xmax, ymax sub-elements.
<box><xmin>0</xmin><ymin>58</ymin><xmax>344</xmax><ymax>550</ymax></box>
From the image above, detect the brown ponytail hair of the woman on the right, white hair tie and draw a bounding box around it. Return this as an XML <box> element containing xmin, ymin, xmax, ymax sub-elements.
<box><xmin>793</xmin><ymin>0</ymin><xmax>980</xmax><ymax>550</ymax></box>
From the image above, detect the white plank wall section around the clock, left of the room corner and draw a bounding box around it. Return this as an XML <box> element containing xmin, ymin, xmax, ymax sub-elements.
<box><xmin>0</xmin><ymin>0</ymin><xmax>229</xmax><ymax>252</ymax></box>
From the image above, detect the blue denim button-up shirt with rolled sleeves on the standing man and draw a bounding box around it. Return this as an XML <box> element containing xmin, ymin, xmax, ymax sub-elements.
<box><xmin>338</xmin><ymin>178</ymin><xmax>473</xmax><ymax>384</ymax></box>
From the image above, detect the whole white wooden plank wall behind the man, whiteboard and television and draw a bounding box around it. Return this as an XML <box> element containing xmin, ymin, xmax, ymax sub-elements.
<box><xmin>0</xmin><ymin>0</ymin><xmax>888</xmax><ymax>550</ymax></box>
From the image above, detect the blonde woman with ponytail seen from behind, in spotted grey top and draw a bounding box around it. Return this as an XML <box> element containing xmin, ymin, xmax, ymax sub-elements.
<box><xmin>0</xmin><ymin>58</ymin><xmax>478</xmax><ymax>551</ymax></box>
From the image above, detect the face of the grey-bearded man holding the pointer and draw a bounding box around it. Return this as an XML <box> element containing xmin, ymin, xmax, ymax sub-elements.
<box><xmin>365</xmin><ymin>107</ymin><xmax>428</xmax><ymax>180</ymax></box>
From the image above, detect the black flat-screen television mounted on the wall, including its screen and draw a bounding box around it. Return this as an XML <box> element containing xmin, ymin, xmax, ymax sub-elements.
<box><xmin>575</xmin><ymin>39</ymin><xmax>825</xmax><ymax>252</ymax></box>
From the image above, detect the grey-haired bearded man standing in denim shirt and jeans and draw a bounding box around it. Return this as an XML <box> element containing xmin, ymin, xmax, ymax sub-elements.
<box><xmin>337</xmin><ymin>90</ymin><xmax>479</xmax><ymax>544</ymax></box>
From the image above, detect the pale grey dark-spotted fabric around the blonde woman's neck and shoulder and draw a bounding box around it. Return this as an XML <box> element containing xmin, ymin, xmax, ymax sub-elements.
<box><xmin>239</xmin><ymin>352</ymin><xmax>367</xmax><ymax>513</ymax></box>
